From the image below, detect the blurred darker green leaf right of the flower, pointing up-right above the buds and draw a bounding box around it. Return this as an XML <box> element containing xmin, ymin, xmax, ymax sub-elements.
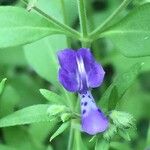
<box><xmin>100</xmin><ymin>63</ymin><xmax>143</xmax><ymax>109</ymax></box>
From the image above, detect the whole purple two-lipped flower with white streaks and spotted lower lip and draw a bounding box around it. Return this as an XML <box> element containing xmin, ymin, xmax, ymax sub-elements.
<box><xmin>58</xmin><ymin>48</ymin><xmax>108</xmax><ymax>135</ymax></box>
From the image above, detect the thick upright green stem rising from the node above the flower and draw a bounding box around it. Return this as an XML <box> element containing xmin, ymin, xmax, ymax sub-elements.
<box><xmin>77</xmin><ymin>0</ymin><xmax>88</xmax><ymax>38</ymax></box>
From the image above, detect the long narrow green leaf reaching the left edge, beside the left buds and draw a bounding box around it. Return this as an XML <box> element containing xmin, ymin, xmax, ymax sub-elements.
<box><xmin>0</xmin><ymin>104</ymin><xmax>51</xmax><ymax>127</ymax></box>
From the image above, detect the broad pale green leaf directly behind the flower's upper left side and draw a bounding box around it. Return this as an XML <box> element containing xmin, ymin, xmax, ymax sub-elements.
<box><xmin>24</xmin><ymin>35</ymin><xmax>67</xmax><ymax>87</ymax></box>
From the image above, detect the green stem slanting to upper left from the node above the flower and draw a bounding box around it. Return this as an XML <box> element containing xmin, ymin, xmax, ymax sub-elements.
<box><xmin>22</xmin><ymin>0</ymin><xmax>80</xmax><ymax>39</ymax></box>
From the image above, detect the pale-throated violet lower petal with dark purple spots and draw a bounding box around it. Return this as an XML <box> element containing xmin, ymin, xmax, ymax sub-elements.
<box><xmin>80</xmin><ymin>91</ymin><xmax>108</xmax><ymax>135</ymax></box>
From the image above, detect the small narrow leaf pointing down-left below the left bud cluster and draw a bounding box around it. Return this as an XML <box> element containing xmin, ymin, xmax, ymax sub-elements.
<box><xmin>50</xmin><ymin>122</ymin><xmax>70</xmax><ymax>141</ymax></box>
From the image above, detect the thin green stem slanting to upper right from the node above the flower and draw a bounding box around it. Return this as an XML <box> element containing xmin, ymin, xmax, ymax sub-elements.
<box><xmin>90</xmin><ymin>0</ymin><xmax>131</xmax><ymax>38</ymax></box>
